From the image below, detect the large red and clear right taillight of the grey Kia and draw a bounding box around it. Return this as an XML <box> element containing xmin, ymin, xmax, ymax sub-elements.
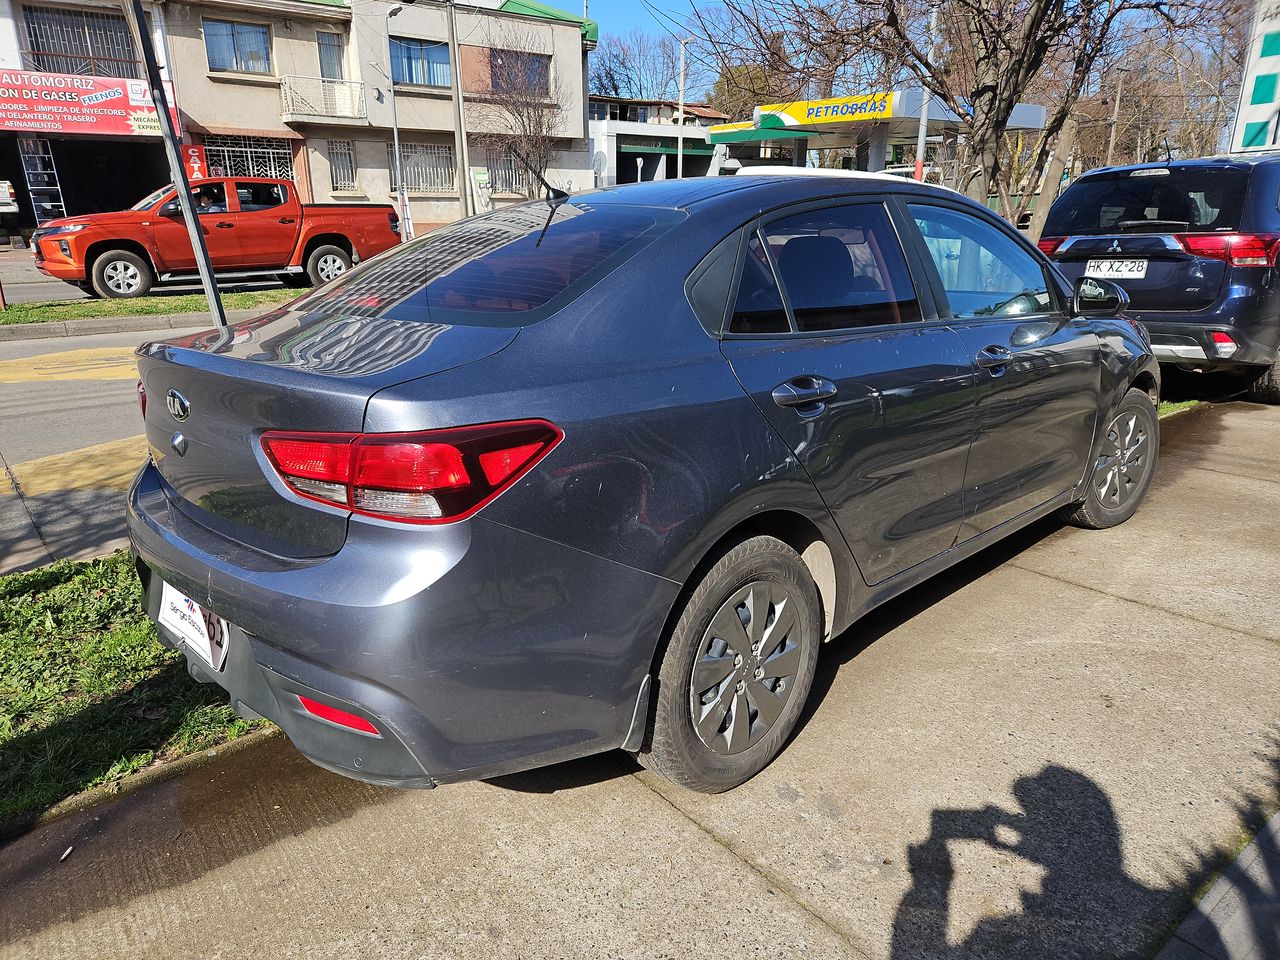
<box><xmin>262</xmin><ymin>420</ymin><xmax>564</xmax><ymax>524</ymax></box>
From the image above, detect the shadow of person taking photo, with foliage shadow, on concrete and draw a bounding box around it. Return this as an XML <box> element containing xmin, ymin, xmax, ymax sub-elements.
<box><xmin>890</xmin><ymin>758</ymin><xmax>1280</xmax><ymax>960</ymax></box>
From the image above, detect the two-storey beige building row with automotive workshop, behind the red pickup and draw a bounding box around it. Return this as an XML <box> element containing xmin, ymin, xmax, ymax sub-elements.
<box><xmin>0</xmin><ymin>0</ymin><xmax>596</xmax><ymax>227</ymax></box>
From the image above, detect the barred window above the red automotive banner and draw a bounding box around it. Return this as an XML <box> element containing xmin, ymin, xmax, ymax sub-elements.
<box><xmin>22</xmin><ymin>6</ymin><xmax>142</xmax><ymax>79</ymax></box>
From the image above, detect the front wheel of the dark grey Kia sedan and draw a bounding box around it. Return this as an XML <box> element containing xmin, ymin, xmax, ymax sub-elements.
<box><xmin>1061</xmin><ymin>388</ymin><xmax>1160</xmax><ymax>530</ymax></box>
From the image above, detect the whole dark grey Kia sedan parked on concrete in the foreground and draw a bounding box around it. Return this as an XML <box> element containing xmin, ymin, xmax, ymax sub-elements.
<box><xmin>128</xmin><ymin>174</ymin><xmax>1160</xmax><ymax>792</ymax></box>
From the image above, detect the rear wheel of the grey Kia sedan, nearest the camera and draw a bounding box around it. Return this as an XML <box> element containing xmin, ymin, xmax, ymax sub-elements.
<box><xmin>637</xmin><ymin>536</ymin><xmax>822</xmax><ymax>794</ymax></box>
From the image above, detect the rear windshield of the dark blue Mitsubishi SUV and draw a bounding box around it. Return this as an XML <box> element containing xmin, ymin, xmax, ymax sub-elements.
<box><xmin>1044</xmin><ymin>166</ymin><xmax>1249</xmax><ymax>237</ymax></box>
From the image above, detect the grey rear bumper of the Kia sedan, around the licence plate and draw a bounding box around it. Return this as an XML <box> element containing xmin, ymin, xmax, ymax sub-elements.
<box><xmin>127</xmin><ymin>465</ymin><xmax>678</xmax><ymax>786</ymax></box>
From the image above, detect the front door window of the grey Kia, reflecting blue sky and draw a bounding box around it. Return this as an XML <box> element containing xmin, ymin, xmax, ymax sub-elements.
<box><xmin>908</xmin><ymin>204</ymin><xmax>1055</xmax><ymax>317</ymax></box>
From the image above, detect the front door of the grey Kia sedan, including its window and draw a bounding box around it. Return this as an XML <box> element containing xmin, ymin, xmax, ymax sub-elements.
<box><xmin>905</xmin><ymin>200</ymin><xmax>1101</xmax><ymax>541</ymax></box>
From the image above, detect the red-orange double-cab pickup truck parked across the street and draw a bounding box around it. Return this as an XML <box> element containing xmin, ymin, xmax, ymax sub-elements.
<box><xmin>31</xmin><ymin>177</ymin><xmax>399</xmax><ymax>298</ymax></box>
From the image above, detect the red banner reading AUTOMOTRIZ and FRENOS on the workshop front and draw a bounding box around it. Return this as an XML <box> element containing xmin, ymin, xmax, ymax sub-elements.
<box><xmin>0</xmin><ymin>70</ymin><xmax>178</xmax><ymax>137</ymax></box>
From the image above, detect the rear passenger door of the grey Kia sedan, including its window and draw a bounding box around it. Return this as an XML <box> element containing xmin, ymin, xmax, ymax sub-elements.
<box><xmin>722</xmin><ymin>197</ymin><xmax>974</xmax><ymax>584</ymax></box>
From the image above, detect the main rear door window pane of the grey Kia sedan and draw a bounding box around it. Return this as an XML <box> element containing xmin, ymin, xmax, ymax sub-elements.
<box><xmin>763</xmin><ymin>204</ymin><xmax>920</xmax><ymax>333</ymax></box>
